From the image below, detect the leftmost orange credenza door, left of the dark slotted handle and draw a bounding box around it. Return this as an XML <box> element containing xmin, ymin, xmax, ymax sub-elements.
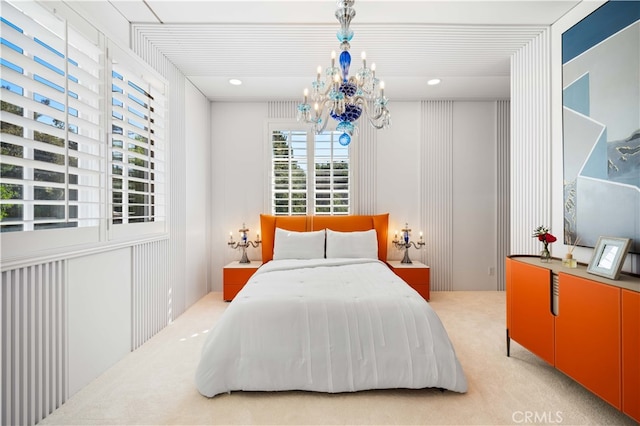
<box><xmin>507</xmin><ymin>259</ymin><xmax>554</xmax><ymax>365</ymax></box>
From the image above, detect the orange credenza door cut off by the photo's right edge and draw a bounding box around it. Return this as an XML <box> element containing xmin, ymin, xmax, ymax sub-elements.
<box><xmin>622</xmin><ymin>289</ymin><xmax>640</xmax><ymax>422</ymax></box>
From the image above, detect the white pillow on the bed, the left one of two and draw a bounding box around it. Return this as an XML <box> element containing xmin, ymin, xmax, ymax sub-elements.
<box><xmin>273</xmin><ymin>228</ymin><xmax>324</xmax><ymax>260</ymax></box>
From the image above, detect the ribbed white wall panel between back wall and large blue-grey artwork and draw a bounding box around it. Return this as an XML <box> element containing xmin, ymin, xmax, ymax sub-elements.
<box><xmin>510</xmin><ymin>29</ymin><xmax>561</xmax><ymax>255</ymax></box>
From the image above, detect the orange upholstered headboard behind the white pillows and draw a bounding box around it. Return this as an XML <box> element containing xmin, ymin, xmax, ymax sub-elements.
<box><xmin>260</xmin><ymin>213</ymin><xmax>389</xmax><ymax>263</ymax></box>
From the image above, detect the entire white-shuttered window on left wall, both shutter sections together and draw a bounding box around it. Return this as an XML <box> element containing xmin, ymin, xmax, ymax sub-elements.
<box><xmin>0</xmin><ymin>1</ymin><xmax>167</xmax><ymax>250</ymax></box>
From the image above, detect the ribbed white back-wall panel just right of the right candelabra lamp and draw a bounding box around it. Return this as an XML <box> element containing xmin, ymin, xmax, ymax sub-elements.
<box><xmin>420</xmin><ymin>101</ymin><xmax>453</xmax><ymax>291</ymax></box>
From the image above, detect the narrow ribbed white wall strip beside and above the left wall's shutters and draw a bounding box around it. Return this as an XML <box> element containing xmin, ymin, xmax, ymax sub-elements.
<box><xmin>131</xmin><ymin>25</ymin><xmax>186</xmax><ymax>320</ymax></box>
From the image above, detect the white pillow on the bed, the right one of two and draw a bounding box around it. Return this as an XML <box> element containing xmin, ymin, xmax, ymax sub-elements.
<box><xmin>327</xmin><ymin>229</ymin><xmax>378</xmax><ymax>259</ymax></box>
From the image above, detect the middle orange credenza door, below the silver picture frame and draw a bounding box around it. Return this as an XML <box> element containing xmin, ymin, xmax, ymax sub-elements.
<box><xmin>556</xmin><ymin>273</ymin><xmax>621</xmax><ymax>409</ymax></box>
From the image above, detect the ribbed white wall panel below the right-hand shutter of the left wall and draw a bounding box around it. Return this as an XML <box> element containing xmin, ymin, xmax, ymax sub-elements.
<box><xmin>131</xmin><ymin>240</ymin><xmax>174</xmax><ymax>350</ymax></box>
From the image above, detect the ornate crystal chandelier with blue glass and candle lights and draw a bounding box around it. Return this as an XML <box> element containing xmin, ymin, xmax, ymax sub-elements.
<box><xmin>297</xmin><ymin>0</ymin><xmax>391</xmax><ymax>146</ymax></box>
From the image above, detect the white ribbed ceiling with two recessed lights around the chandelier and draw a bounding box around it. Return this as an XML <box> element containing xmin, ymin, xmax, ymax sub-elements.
<box><xmin>77</xmin><ymin>0</ymin><xmax>588</xmax><ymax>101</ymax></box>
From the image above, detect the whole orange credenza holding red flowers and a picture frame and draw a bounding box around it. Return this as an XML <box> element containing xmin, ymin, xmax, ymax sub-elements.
<box><xmin>505</xmin><ymin>256</ymin><xmax>640</xmax><ymax>422</ymax></box>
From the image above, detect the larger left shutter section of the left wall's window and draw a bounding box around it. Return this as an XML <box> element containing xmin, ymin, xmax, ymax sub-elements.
<box><xmin>0</xmin><ymin>2</ymin><xmax>102</xmax><ymax>232</ymax></box>
